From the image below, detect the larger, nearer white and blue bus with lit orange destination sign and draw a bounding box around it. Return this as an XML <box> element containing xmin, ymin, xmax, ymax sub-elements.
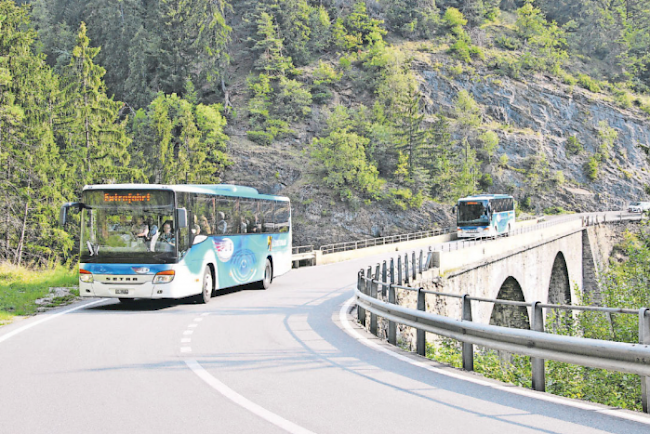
<box><xmin>61</xmin><ymin>184</ymin><xmax>291</xmax><ymax>303</ymax></box>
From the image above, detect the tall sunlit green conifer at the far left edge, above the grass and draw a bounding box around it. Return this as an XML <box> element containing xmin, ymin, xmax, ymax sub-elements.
<box><xmin>0</xmin><ymin>1</ymin><xmax>72</xmax><ymax>265</ymax></box>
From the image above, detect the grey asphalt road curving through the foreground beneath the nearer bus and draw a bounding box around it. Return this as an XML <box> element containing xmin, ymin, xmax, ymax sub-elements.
<box><xmin>0</xmin><ymin>246</ymin><xmax>650</xmax><ymax>434</ymax></box>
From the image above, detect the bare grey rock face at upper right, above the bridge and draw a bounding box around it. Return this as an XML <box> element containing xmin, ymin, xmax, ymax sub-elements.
<box><xmin>420</xmin><ymin>65</ymin><xmax>650</xmax><ymax>212</ymax></box>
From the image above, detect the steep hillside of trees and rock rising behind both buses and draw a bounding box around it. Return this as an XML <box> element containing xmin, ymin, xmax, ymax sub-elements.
<box><xmin>7</xmin><ymin>0</ymin><xmax>650</xmax><ymax>264</ymax></box>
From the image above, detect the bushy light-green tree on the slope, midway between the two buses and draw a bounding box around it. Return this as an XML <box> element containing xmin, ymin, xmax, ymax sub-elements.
<box><xmin>311</xmin><ymin>106</ymin><xmax>382</xmax><ymax>201</ymax></box>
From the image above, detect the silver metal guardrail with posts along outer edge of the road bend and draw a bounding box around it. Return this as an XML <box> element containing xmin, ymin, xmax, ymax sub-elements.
<box><xmin>356</xmin><ymin>214</ymin><xmax>650</xmax><ymax>413</ymax></box>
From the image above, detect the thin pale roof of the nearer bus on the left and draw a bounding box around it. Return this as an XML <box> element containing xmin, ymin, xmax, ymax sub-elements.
<box><xmin>83</xmin><ymin>184</ymin><xmax>289</xmax><ymax>201</ymax></box>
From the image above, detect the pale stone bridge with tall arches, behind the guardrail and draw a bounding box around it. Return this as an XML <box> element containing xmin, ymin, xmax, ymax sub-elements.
<box><xmin>417</xmin><ymin>216</ymin><xmax>627</xmax><ymax>328</ymax></box>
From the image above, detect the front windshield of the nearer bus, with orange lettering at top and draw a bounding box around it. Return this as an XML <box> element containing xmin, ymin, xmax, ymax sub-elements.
<box><xmin>80</xmin><ymin>190</ymin><xmax>177</xmax><ymax>264</ymax></box>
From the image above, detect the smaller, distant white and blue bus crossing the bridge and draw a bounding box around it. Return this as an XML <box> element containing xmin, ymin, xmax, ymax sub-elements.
<box><xmin>456</xmin><ymin>194</ymin><xmax>515</xmax><ymax>238</ymax></box>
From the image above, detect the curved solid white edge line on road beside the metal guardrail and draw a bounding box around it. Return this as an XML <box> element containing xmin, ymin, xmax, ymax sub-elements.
<box><xmin>339</xmin><ymin>297</ymin><xmax>650</xmax><ymax>425</ymax></box>
